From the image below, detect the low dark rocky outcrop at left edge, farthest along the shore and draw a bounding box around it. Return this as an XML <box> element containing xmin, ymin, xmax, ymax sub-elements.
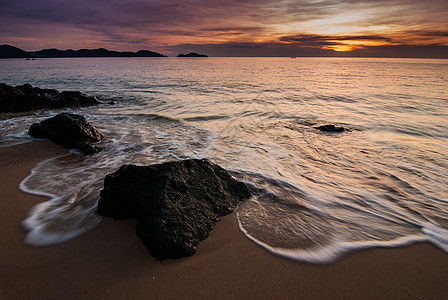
<box><xmin>0</xmin><ymin>83</ymin><xmax>101</xmax><ymax>113</ymax></box>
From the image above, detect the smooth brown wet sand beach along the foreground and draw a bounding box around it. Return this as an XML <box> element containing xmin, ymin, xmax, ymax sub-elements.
<box><xmin>0</xmin><ymin>141</ymin><xmax>448</xmax><ymax>299</ymax></box>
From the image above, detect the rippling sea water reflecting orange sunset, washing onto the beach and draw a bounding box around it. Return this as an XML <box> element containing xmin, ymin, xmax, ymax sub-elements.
<box><xmin>0</xmin><ymin>58</ymin><xmax>448</xmax><ymax>263</ymax></box>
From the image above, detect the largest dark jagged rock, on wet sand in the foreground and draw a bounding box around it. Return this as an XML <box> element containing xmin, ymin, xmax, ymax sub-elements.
<box><xmin>98</xmin><ymin>159</ymin><xmax>251</xmax><ymax>260</ymax></box>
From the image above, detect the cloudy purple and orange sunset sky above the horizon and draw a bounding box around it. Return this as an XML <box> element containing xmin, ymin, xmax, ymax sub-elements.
<box><xmin>0</xmin><ymin>0</ymin><xmax>448</xmax><ymax>58</ymax></box>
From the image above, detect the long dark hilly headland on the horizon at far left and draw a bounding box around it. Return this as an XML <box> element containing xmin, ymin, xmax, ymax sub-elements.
<box><xmin>0</xmin><ymin>45</ymin><xmax>166</xmax><ymax>58</ymax></box>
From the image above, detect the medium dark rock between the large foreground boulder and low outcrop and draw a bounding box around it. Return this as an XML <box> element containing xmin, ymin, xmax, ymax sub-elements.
<box><xmin>28</xmin><ymin>113</ymin><xmax>106</xmax><ymax>154</ymax></box>
